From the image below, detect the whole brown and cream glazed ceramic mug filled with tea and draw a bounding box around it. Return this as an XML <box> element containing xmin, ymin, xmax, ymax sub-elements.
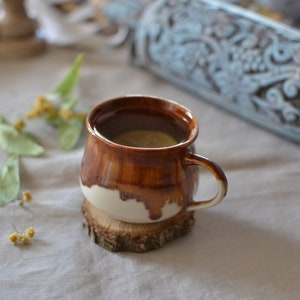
<box><xmin>80</xmin><ymin>95</ymin><xmax>227</xmax><ymax>223</ymax></box>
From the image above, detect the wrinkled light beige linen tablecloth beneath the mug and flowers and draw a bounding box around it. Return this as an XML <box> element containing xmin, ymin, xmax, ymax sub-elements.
<box><xmin>0</xmin><ymin>42</ymin><xmax>300</xmax><ymax>300</ymax></box>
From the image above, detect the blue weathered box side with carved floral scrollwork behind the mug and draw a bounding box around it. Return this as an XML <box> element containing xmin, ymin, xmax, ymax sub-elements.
<box><xmin>133</xmin><ymin>0</ymin><xmax>300</xmax><ymax>141</ymax></box>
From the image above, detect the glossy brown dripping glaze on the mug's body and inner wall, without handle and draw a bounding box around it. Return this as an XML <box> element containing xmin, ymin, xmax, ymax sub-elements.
<box><xmin>81</xmin><ymin>96</ymin><xmax>198</xmax><ymax>220</ymax></box>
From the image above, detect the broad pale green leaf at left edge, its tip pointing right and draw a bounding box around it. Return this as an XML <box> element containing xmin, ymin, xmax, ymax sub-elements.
<box><xmin>0</xmin><ymin>124</ymin><xmax>44</xmax><ymax>156</ymax></box>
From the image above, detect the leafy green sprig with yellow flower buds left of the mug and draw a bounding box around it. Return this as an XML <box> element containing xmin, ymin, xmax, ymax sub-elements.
<box><xmin>0</xmin><ymin>54</ymin><xmax>86</xmax><ymax>206</ymax></box>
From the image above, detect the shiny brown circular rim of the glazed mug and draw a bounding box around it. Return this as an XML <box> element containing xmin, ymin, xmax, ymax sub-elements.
<box><xmin>86</xmin><ymin>94</ymin><xmax>199</xmax><ymax>152</ymax></box>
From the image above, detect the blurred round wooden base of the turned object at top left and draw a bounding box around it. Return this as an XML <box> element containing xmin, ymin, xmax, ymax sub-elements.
<box><xmin>0</xmin><ymin>37</ymin><xmax>46</xmax><ymax>59</ymax></box>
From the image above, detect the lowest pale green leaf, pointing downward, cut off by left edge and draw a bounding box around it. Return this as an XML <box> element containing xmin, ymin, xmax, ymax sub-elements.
<box><xmin>0</xmin><ymin>155</ymin><xmax>20</xmax><ymax>206</ymax></box>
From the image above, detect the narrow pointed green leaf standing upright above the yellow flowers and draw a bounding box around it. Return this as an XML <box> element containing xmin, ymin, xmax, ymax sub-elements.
<box><xmin>54</xmin><ymin>54</ymin><xmax>84</xmax><ymax>97</ymax></box>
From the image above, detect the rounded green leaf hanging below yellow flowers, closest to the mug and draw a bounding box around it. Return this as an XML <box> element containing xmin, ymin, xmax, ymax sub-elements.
<box><xmin>58</xmin><ymin>119</ymin><xmax>84</xmax><ymax>151</ymax></box>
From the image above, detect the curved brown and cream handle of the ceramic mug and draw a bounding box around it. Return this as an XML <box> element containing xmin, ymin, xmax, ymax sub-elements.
<box><xmin>185</xmin><ymin>153</ymin><xmax>228</xmax><ymax>211</ymax></box>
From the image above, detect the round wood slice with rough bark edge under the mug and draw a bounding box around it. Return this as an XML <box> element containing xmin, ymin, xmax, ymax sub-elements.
<box><xmin>82</xmin><ymin>200</ymin><xmax>195</xmax><ymax>252</ymax></box>
